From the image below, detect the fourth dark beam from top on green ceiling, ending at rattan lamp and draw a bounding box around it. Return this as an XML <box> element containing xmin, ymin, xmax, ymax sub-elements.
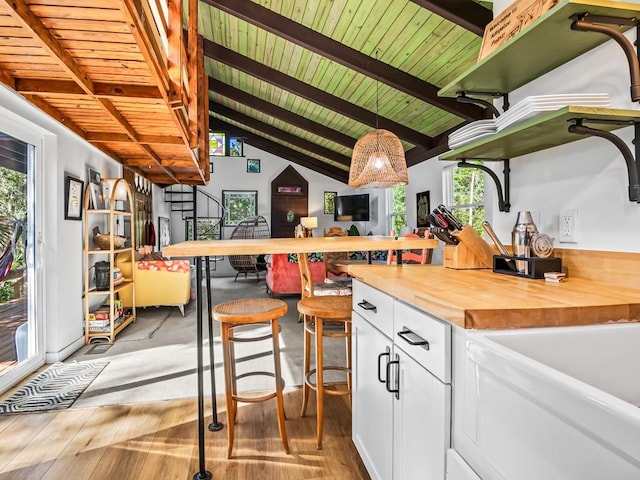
<box><xmin>209</xmin><ymin>77</ymin><xmax>357</xmax><ymax>148</ymax></box>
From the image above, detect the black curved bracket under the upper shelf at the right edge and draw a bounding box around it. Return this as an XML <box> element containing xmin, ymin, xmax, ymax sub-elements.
<box><xmin>571</xmin><ymin>12</ymin><xmax>640</xmax><ymax>102</ymax></box>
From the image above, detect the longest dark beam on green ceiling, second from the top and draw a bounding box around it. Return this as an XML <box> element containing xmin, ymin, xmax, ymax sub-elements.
<box><xmin>203</xmin><ymin>0</ymin><xmax>483</xmax><ymax>120</ymax></box>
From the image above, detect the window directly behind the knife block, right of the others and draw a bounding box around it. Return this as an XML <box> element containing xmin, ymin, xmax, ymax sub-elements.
<box><xmin>442</xmin><ymin>165</ymin><xmax>484</xmax><ymax>235</ymax></box>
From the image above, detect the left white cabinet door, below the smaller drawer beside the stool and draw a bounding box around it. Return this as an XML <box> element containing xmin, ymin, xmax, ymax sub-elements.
<box><xmin>352</xmin><ymin>312</ymin><xmax>393</xmax><ymax>480</ymax></box>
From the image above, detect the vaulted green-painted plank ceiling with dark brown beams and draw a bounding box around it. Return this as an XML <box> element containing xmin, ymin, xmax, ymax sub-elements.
<box><xmin>198</xmin><ymin>0</ymin><xmax>491</xmax><ymax>183</ymax></box>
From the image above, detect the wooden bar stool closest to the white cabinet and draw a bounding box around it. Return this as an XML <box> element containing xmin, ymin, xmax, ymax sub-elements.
<box><xmin>298</xmin><ymin>296</ymin><xmax>352</xmax><ymax>449</ymax></box>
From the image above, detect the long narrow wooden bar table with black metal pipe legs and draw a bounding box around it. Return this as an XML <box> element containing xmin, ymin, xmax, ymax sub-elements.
<box><xmin>162</xmin><ymin>235</ymin><xmax>439</xmax><ymax>480</ymax></box>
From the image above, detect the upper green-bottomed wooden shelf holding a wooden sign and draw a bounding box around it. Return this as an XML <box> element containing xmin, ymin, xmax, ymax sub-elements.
<box><xmin>438</xmin><ymin>0</ymin><xmax>640</xmax><ymax>97</ymax></box>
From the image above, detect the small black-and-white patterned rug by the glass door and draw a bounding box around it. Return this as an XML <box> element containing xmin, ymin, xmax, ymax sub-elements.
<box><xmin>0</xmin><ymin>362</ymin><xmax>109</xmax><ymax>414</ymax></box>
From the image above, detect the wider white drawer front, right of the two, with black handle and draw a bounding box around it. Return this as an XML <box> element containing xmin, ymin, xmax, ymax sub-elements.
<box><xmin>393</xmin><ymin>300</ymin><xmax>451</xmax><ymax>383</ymax></box>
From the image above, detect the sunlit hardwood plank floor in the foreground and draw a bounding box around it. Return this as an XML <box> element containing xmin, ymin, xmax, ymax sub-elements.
<box><xmin>0</xmin><ymin>389</ymin><xmax>369</xmax><ymax>480</ymax></box>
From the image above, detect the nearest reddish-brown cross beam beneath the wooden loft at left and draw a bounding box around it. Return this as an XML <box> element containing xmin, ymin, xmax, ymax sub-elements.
<box><xmin>14</xmin><ymin>78</ymin><xmax>162</xmax><ymax>100</ymax></box>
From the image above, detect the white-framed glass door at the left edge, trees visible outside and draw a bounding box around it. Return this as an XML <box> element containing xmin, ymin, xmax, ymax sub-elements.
<box><xmin>0</xmin><ymin>109</ymin><xmax>44</xmax><ymax>392</ymax></box>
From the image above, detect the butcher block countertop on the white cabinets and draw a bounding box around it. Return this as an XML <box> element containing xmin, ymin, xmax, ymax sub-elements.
<box><xmin>349</xmin><ymin>265</ymin><xmax>640</xmax><ymax>329</ymax></box>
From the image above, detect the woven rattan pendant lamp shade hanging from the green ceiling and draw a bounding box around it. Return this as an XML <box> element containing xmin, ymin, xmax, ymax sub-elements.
<box><xmin>349</xmin><ymin>129</ymin><xmax>409</xmax><ymax>188</ymax></box>
